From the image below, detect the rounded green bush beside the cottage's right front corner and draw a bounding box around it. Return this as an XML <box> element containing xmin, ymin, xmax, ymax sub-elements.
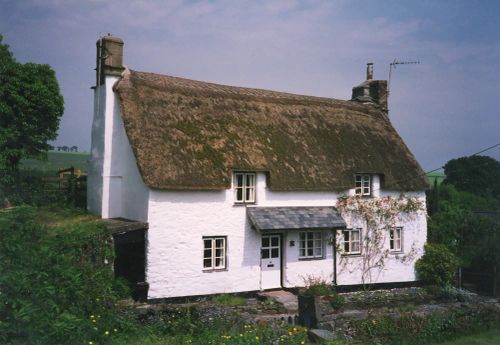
<box><xmin>415</xmin><ymin>244</ymin><xmax>459</xmax><ymax>286</ymax></box>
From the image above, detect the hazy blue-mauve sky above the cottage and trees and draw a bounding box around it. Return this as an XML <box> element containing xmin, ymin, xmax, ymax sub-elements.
<box><xmin>0</xmin><ymin>0</ymin><xmax>500</xmax><ymax>171</ymax></box>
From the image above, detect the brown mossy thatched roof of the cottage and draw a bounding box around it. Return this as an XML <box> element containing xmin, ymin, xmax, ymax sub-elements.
<box><xmin>115</xmin><ymin>71</ymin><xmax>427</xmax><ymax>191</ymax></box>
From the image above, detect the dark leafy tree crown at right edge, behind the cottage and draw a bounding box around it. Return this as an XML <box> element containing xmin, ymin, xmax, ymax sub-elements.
<box><xmin>444</xmin><ymin>156</ymin><xmax>500</xmax><ymax>199</ymax></box>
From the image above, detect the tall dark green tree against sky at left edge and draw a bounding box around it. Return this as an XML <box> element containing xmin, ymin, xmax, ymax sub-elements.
<box><xmin>0</xmin><ymin>35</ymin><xmax>64</xmax><ymax>173</ymax></box>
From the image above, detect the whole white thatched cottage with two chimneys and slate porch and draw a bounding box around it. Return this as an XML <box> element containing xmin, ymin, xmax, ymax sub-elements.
<box><xmin>88</xmin><ymin>35</ymin><xmax>427</xmax><ymax>299</ymax></box>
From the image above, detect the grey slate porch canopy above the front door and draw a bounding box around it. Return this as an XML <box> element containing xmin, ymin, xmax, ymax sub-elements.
<box><xmin>247</xmin><ymin>206</ymin><xmax>347</xmax><ymax>232</ymax></box>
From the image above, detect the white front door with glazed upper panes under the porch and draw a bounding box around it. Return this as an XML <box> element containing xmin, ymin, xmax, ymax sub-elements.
<box><xmin>260</xmin><ymin>235</ymin><xmax>281</xmax><ymax>290</ymax></box>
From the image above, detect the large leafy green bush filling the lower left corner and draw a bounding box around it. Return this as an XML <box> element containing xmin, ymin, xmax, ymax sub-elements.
<box><xmin>0</xmin><ymin>207</ymin><xmax>133</xmax><ymax>344</ymax></box>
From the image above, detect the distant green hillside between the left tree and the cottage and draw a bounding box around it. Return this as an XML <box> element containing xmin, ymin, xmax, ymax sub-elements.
<box><xmin>21</xmin><ymin>151</ymin><xmax>90</xmax><ymax>175</ymax></box>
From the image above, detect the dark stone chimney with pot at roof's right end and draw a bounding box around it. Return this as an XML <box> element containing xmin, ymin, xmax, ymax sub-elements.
<box><xmin>351</xmin><ymin>62</ymin><xmax>389</xmax><ymax>113</ymax></box>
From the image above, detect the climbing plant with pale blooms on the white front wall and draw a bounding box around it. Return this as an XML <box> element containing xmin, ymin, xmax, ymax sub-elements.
<box><xmin>337</xmin><ymin>194</ymin><xmax>425</xmax><ymax>286</ymax></box>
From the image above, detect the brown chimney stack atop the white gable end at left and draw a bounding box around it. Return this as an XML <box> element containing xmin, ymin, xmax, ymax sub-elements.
<box><xmin>96</xmin><ymin>34</ymin><xmax>125</xmax><ymax>85</ymax></box>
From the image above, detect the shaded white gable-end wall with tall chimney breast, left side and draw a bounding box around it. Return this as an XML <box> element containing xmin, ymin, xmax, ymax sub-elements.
<box><xmin>87</xmin><ymin>76</ymin><xmax>149</xmax><ymax>221</ymax></box>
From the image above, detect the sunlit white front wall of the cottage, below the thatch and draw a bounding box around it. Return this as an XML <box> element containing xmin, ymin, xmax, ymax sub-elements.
<box><xmin>147</xmin><ymin>173</ymin><xmax>426</xmax><ymax>299</ymax></box>
